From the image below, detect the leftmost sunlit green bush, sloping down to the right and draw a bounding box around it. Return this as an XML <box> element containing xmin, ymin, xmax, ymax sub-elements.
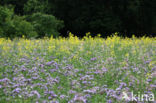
<box><xmin>0</xmin><ymin>6</ymin><xmax>37</xmax><ymax>38</ymax></box>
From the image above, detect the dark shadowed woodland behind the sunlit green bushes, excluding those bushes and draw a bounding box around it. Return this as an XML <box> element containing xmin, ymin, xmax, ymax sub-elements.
<box><xmin>0</xmin><ymin>0</ymin><xmax>156</xmax><ymax>36</ymax></box>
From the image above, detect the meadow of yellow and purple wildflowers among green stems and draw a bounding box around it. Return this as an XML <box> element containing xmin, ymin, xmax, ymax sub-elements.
<box><xmin>0</xmin><ymin>33</ymin><xmax>156</xmax><ymax>103</ymax></box>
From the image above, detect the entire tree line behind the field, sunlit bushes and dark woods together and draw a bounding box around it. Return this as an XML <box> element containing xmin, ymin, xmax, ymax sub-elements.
<box><xmin>0</xmin><ymin>0</ymin><xmax>156</xmax><ymax>37</ymax></box>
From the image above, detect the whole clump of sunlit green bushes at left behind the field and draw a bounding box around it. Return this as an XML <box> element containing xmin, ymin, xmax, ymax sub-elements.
<box><xmin>0</xmin><ymin>6</ymin><xmax>63</xmax><ymax>38</ymax></box>
